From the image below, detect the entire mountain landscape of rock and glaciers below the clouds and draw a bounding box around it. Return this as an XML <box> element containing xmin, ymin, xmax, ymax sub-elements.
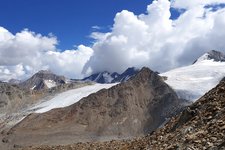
<box><xmin>0</xmin><ymin>50</ymin><xmax>225</xmax><ymax>149</ymax></box>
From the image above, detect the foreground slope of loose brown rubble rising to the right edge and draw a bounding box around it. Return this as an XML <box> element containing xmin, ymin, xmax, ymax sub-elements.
<box><xmin>24</xmin><ymin>78</ymin><xmax>225</xmax><ymax>150</ymax></box>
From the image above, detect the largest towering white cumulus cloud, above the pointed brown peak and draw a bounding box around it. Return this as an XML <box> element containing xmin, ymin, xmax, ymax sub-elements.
<box><xmin>84</xmin><ymin>0</ymin><xmax>225</xmax><ymax>72</ymax></box>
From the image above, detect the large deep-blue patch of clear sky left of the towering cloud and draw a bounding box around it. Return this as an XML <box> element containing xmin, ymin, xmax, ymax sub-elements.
<box><xmin>0</xmin><ymin>0</ymin><xmax>155</xmax><ymax>49</ymax></box>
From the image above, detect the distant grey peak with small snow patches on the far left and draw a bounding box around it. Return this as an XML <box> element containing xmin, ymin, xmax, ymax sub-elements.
<box><xmin>19</xmin><ymin>70</ymin><xmax>66</xmax><ymax>90</ymax></box>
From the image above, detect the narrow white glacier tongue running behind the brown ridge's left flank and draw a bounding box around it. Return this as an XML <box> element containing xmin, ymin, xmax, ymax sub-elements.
<box><xmin>29</xmin><ymin>83</ymin><xmax>118</xmax><ymax>113</ymax></box>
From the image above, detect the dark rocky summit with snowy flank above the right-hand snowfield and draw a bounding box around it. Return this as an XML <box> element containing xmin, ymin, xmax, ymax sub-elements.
<box><xmin>193</xmin><ymin>50</ymin><xmax>225</xmax><ymax>64</ymax></box>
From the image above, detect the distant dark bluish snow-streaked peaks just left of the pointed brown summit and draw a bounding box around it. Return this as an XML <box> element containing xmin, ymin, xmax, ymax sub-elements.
<box><xmin>82</xmin><ymin>67</ymin><xmax>139</xmax><ymax>83</ymax></box>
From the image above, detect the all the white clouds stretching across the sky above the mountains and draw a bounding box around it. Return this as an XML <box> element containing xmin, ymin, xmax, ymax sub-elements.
<box><xmin>0</xmin><ymin>0</ymin><xmax>225</xmax><ymax>80</ymax></box>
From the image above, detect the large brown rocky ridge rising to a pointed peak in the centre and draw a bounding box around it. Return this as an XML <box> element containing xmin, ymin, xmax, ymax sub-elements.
<box><xmin>4</xmin><ymin>68</ymin><xmax>185</xmax><ymax>145</ymax></box>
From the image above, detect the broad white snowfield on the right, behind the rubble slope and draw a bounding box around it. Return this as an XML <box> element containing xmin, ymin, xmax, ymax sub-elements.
<box><xmin>160</xmin><ymin>59</ymin><xmax>225</xmax><ymax>101</ymax></box>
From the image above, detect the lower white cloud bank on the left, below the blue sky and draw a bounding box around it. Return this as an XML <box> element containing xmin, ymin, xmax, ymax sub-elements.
<box><xmin>0</xmin><ymin>27</ymin><xmax>93</xmax><ymax>81</ymax></box>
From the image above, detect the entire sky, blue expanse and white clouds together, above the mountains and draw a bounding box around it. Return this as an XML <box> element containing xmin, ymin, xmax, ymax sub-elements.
<box><xmin>0</xmin><ymin>0</ymin><xmax>225</xmax><ymax>81</ymax></box>
